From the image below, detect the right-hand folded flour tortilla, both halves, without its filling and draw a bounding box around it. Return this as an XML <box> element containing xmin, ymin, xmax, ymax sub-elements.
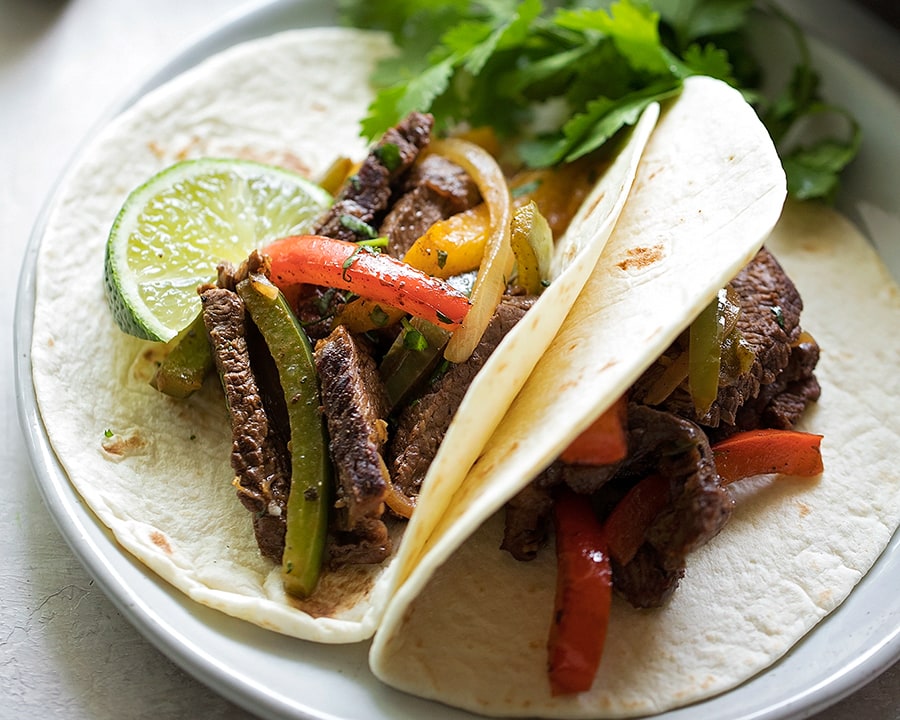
<box><xmin>370</xmin><ymin>80</ymin><xmax>900</xmax><ymax>718</ymax></box>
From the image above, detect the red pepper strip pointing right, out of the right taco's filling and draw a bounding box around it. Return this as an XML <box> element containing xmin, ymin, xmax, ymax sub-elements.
<box><xmin>712</xmin><ymin>430</ymin><xmax>824</xmax><ymax>483</ymax></box>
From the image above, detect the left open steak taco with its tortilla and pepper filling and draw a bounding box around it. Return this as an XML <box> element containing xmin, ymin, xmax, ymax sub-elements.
<box><xmin>32</xmin><ymin>29</ymin><xmax>660</xmax><ymax>643</ymax></box>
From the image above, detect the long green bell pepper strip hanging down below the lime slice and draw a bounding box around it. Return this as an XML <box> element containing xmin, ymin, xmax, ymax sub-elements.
<box><xmin>237</xmin><ymin>275</ymin><xmax>331</xmax><ymax>597</ymax></box>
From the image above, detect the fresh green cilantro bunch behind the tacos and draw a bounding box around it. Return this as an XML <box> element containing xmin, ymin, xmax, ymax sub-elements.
<box><xmin>338</xmin><ymin>0</ymin><xmax>860</xmax><ymax>199</ymax></box>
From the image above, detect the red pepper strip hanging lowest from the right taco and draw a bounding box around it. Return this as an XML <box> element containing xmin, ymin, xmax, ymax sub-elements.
<box><xmin>547</xmin><ymin>491</ymin><xmax>612</xmax><ymax>696</ymax></box>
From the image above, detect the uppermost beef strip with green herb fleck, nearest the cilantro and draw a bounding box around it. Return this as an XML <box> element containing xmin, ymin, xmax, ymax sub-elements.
<box><xmin>316</xmin><ymin>112</ymin><xmax>434</xmax><ymax>241</ymax></box>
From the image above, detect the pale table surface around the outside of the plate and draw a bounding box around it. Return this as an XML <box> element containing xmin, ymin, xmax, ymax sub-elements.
<box><xmin>0</xmin><ymin>0</ymin><xmax>900</xmax><ymax>720</ymax></box>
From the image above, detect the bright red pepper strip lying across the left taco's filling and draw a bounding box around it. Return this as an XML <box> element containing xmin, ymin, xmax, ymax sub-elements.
<box><xmin>263</xmin><ymin>235</ymin><xmax>469</xmax><ymax>330</ymax></box>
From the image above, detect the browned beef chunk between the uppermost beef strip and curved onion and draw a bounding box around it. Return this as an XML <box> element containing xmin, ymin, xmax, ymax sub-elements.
<box><xmin>378</xmin><ymin>155</ymin><xmax>481</xmax><ymax>258</ymax></box>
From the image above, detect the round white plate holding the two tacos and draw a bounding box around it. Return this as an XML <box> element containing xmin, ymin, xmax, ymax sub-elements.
<box><xmin>15</xmin><ymin>0</ymin><xmax>900</xmax><ymax>720</ymax></box>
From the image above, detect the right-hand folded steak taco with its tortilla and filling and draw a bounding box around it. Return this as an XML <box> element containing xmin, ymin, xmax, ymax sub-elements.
<box><xmin>370</xmin><ymin>80</ymin><xmax>900</xmax><ymax>718</ymax></box>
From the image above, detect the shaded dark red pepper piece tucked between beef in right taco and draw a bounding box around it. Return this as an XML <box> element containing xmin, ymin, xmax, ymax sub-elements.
<box><xmin>603</xmin><ymin>475</ymin><xmax>669</xmax><ymax>565</ymax></box>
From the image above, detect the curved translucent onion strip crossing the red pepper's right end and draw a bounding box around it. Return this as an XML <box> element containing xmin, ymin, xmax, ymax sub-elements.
<box><xmin>429</xmin><ymin>138</ymin><xmax>515</xmax><ymax>363</ymax></box>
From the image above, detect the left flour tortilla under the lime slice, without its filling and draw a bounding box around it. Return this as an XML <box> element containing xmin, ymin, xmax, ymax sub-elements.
<box><xmin>32</xmin><ymin>28</ymin><xmax>658</xmax><ymax>643</ymax></box>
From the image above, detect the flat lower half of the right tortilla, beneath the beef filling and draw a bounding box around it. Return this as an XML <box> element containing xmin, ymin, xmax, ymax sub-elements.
<box><xmin>371</xmin><ymin>211</ymin><xmax>900</xmax><ymax>718</ymax></box>
